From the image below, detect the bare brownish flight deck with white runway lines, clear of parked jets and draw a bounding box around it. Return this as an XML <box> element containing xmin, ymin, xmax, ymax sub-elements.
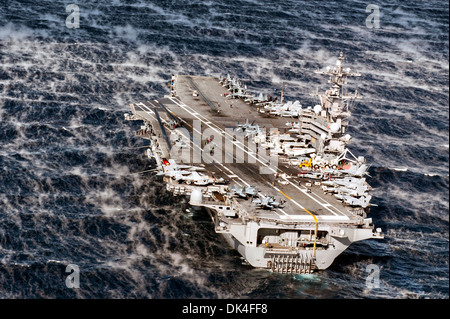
<box><xmin>134</xmin><ymin>75</ymin><xmax>355</xmax><ymax>222</ymax></box>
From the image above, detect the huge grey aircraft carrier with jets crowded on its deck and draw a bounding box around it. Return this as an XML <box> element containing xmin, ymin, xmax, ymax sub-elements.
<box><xmin>125</xmin><ymin>53</ymin><xmax>383</xmax><ymax>273</ymax></box>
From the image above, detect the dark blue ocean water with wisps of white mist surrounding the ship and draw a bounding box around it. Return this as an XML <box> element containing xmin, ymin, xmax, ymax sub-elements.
<box><xmin>0</xmin><ymin>0</ymin><xmax>449</xmax><ymax>299</ymax></box>
